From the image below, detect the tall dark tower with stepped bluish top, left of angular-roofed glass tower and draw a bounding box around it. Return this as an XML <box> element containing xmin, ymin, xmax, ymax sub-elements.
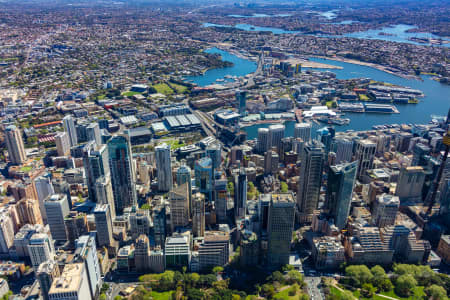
<box><xmin>297</xmin><ymin>140</ymin><xmax>325</xmax><ymax>223</ymax></box>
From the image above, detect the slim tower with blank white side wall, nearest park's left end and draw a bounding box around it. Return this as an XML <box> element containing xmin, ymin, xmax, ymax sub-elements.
<box><xmin>73</xmin><ymin>233</ymin><xmax>102</xmax><ymax>299</ymax></box>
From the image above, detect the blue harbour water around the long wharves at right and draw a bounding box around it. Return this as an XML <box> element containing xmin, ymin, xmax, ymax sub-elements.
<box><xmin>245</xmin><ymin>58</ymin><xmax>450</xmax><ymax>139</ymax></box>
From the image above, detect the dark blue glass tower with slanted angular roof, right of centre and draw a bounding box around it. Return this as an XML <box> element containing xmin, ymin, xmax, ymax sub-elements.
<box><xmin>327</xmin><ymin>161</ymin><xmax>358</xmax><ymax>229</ymax></box>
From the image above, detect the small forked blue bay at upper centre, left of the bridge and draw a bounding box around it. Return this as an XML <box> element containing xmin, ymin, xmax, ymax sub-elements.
<box><xmin>185</xmin><ymin>48</ymin><xmax>257</xmax><ymax>86</ymax></box>
